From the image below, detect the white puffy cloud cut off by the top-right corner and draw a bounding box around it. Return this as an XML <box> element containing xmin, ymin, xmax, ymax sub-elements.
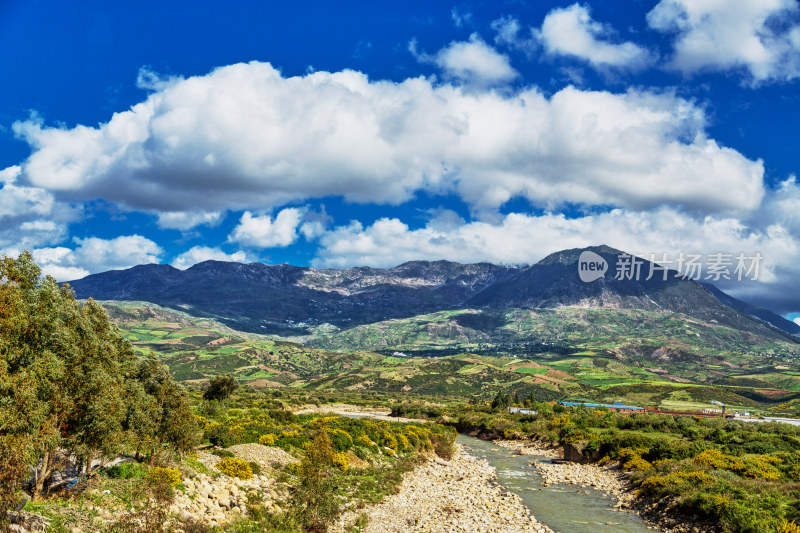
<box><xmin>647</xmin><ymin>0</ymin><xmax>800</xmax><ymax>83</ymax></box>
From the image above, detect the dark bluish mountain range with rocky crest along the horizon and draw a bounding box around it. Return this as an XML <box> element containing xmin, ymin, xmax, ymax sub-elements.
<box><xmin>69</xmin><ymin>246</ymin><xmax>800</xmax><ymax>340</ymax></box>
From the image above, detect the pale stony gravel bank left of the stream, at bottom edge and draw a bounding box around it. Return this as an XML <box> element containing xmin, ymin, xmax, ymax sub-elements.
<box><xmin>336</xmin><ymin>445</ymin><xmax>552</xmax><ymax>533</ymax></box>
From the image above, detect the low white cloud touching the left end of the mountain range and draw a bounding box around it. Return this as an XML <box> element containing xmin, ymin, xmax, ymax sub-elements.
<box><xmin>33</xmin><ymin>235</ymin><xmax>164</xmax><ymax>281</ymax></box>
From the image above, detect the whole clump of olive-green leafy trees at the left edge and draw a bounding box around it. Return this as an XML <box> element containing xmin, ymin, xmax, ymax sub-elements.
<box><xmin>0</xmin><ymin>252</ymin><xmax>197</xmax><ymax>510</ymax></box>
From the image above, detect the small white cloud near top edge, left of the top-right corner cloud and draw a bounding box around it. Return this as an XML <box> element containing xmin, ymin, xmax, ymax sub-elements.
<box><xmin>536</xmin><ymin>4</ymin><xmax>654</xmax><ymax>69</ymax></box>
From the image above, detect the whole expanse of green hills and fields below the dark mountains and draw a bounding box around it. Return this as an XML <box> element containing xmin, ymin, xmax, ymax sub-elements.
<box><xmin>102</xmin><ymin>302</ymin><xmax>800</xmax><ymax>409</ymax></box>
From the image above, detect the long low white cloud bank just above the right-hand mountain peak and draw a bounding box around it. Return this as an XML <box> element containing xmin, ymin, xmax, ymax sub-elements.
<box><xmin>317</xmin><ymin>208</ymin><xmax>794</xmax><ymax>266</ymax></box>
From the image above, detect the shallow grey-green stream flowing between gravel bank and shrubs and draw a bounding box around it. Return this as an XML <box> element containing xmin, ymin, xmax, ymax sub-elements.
<box><xmin>457</xmin><ymin>435</ymin><xmax>652</xmax><ymax>533</ymax></box>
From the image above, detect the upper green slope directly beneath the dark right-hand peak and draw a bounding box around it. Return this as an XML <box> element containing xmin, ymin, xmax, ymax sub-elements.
<box><xmin>298</xmin><ymin>307</ymin><xmax>800</xmax><ymax>356</ymax></box>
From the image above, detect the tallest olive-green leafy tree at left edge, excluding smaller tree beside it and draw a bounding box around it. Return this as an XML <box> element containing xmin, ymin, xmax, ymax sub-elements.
<box><xmin>0</xmin><ymin>252</ymin><xmax>135</xmax><ymax>498</ymax></box>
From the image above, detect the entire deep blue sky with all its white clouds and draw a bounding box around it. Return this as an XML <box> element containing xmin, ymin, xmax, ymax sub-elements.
<box><xmin>0</xmin><ymin>0</ymin><xmax>800</xmax><ymax>317</ymax></box>
